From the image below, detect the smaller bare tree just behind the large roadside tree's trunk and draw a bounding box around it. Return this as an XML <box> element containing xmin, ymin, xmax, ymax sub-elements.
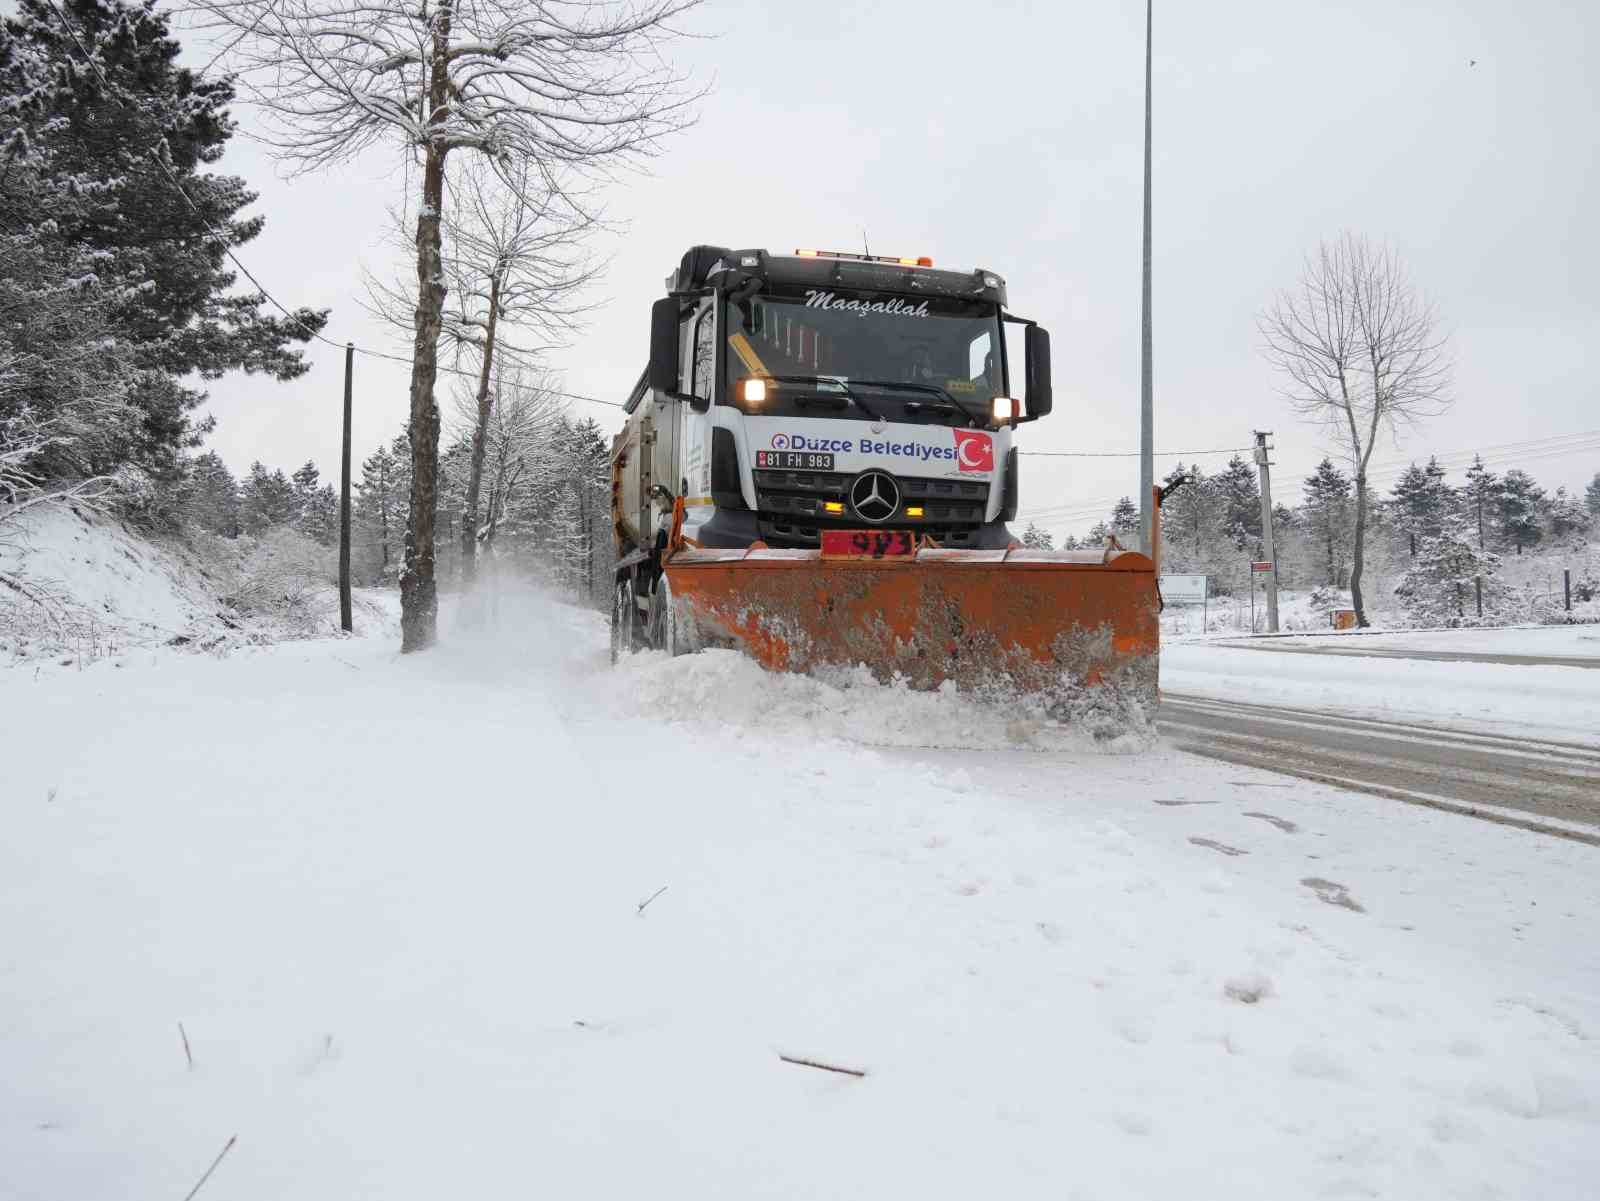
<box><xmin>368</xmin><ymin>157</ymin><xmax>598</xmax><ymax>581</ymax></box>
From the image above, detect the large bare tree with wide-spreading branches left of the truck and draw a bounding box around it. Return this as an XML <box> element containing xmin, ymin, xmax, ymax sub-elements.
<box><xmin>192</xmin><ymin>0</ymin><xmax>698</xmax><ymax>651</ymax></box>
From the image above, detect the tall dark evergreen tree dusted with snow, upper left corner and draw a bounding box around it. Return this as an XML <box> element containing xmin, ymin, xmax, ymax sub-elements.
<box><xmin>0</xmin><ymin>0</ymin><xmax>326</xmax><ymax>475</ymax></box>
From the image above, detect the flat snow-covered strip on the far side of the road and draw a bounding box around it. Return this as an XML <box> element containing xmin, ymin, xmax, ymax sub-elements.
<box><xmin>1162</xmin><ymin>625</ymin><xmax>1600</xmax><ymax>748</ymax></box>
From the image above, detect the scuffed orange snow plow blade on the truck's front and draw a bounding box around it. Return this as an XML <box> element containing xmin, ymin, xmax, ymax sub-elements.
<box><xmin>666</xmin><ymin>547</ymin><xmax>1160</xmax><ymax>732</ymax></box>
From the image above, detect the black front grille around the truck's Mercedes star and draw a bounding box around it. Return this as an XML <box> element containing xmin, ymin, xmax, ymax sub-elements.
<box><xmin>755</xmin><ymin>470</ymin><xmax>989</xmax><ymax>547</ymax></box>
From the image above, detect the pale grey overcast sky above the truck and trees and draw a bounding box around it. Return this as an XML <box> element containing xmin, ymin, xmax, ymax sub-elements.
<box><xmin>190</xmin><ymin>0</ymin><xmax>1600</xmax><ymax>534</ymax></box>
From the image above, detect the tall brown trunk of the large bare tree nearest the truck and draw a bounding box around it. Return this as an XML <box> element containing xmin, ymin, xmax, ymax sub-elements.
<box><xmin>400</xmin><ymin>0</ymin><xmax>451</xmax><ymax>652</ymax></box>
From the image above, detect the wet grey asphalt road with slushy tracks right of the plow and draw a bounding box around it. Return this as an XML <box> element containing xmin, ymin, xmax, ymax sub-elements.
<box><xmin>1160</xmin><ymin>694</ymin><xmax>1600</xmax><ymax>846</ymax></box>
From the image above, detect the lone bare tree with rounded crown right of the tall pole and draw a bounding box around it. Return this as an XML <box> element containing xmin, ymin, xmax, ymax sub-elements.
<box><xmin>1258</xmin><ymin>233</ymin><xmax>1450</xmax><ymax>625</ymax></box>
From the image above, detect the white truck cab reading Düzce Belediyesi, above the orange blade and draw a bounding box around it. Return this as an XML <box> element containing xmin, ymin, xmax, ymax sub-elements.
<box><xmin>613</xmin><ymin>246</ymin><xmax>1050</xmax><ymax>562</ymax></box>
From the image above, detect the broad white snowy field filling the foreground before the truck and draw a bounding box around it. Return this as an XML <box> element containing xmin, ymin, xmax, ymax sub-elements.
<box><xmin>0</xmin><ymin>600</ymin><xmax>1600</xmax><ymax>1201</ymax></box>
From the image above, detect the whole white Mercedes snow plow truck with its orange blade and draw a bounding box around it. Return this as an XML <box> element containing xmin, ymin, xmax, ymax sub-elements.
<box><xmin>611</xmin><ymin>246</ymin><xmax>1160</xmax><ymax>728</ymax></box>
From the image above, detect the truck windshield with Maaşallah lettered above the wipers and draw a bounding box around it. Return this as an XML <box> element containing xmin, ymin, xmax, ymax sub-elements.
<box><xmin>726</xmin><ymin>289</ymin><xmax>1005</xmax><ymax>425</ymax></box>
